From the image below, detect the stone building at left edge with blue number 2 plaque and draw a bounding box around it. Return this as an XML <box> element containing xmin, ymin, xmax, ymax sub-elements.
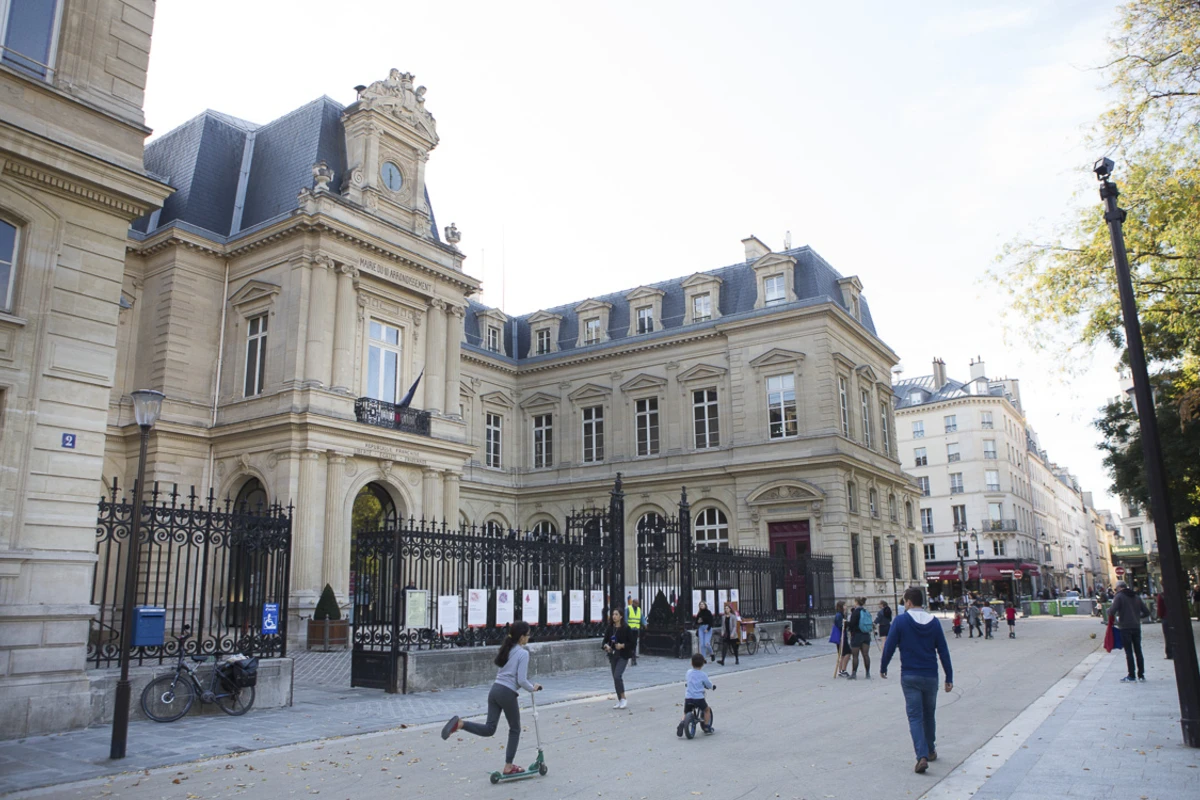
<box><xmin>0</xmin><ymin>0</ymin><xmax>169</xmax><ymax>736</ymax></box>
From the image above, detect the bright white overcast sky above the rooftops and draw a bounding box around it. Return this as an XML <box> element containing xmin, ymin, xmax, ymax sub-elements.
<box><xmin>145</xmin><ymin>0</ymin><xmax>1120</xmax><ymax>510</ymax></box>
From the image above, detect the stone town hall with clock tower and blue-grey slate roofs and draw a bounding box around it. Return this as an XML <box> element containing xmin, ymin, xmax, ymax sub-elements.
<box><xmin>106</xmin><ymin>71</ymin><xmax>923</xmax><ymax>652</ymax></box>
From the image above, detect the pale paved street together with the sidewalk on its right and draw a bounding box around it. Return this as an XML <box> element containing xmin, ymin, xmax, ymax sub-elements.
<box><xmin>4</xmin><ymin>619</ymin><xmax>1200</xmax><ymax>800</ymax></box>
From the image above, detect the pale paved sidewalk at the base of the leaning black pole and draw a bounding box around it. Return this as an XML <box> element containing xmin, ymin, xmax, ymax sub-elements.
<box><xmin>922</xmin><ymin>621</ymin><xmax>1200</xmax><ymax>800</ymax></box>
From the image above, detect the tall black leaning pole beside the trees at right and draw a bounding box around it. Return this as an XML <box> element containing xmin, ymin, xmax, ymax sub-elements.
<box><xmin>1096</xmin><ymin>164</ymin><xmax>1200</xmax><ymax>747</ymax></box>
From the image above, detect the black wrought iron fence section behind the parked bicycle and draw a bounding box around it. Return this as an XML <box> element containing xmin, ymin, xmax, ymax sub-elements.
<box><xmin>88</xmin><ymin>479</ymin><xmax>292</xmax><ymax>667</ymax></box>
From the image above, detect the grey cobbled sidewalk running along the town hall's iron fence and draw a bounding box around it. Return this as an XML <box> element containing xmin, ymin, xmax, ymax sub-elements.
<box><xmin>0</xmin><ymin>643</ymin><xmax>834</xmax><ymax>794</ymax></box>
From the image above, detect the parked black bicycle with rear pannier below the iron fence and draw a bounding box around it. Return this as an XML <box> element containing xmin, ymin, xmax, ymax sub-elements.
<box><xmin>142</xmin><ymin>625</ymin><xmax>258</xmax><ymax>722</ymax></box>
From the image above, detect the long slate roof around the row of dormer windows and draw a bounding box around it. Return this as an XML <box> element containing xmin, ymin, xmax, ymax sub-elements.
<box><xmin>464</xmin><ymin>246</ymin><xmax>878</xmax><ymax>365</ymax></box>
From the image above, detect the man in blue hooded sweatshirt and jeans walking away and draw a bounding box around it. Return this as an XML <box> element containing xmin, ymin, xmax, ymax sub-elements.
<box><xmin>880</xmin><ymin>587</ymin><xmax>954</xmax><ymax>774</ymax></box>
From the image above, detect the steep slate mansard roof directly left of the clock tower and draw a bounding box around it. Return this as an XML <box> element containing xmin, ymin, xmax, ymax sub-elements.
<box><xmin>126</xmin><ymin>97</ymin><xmax>440</xmax><ymax>242</ymax></box>
